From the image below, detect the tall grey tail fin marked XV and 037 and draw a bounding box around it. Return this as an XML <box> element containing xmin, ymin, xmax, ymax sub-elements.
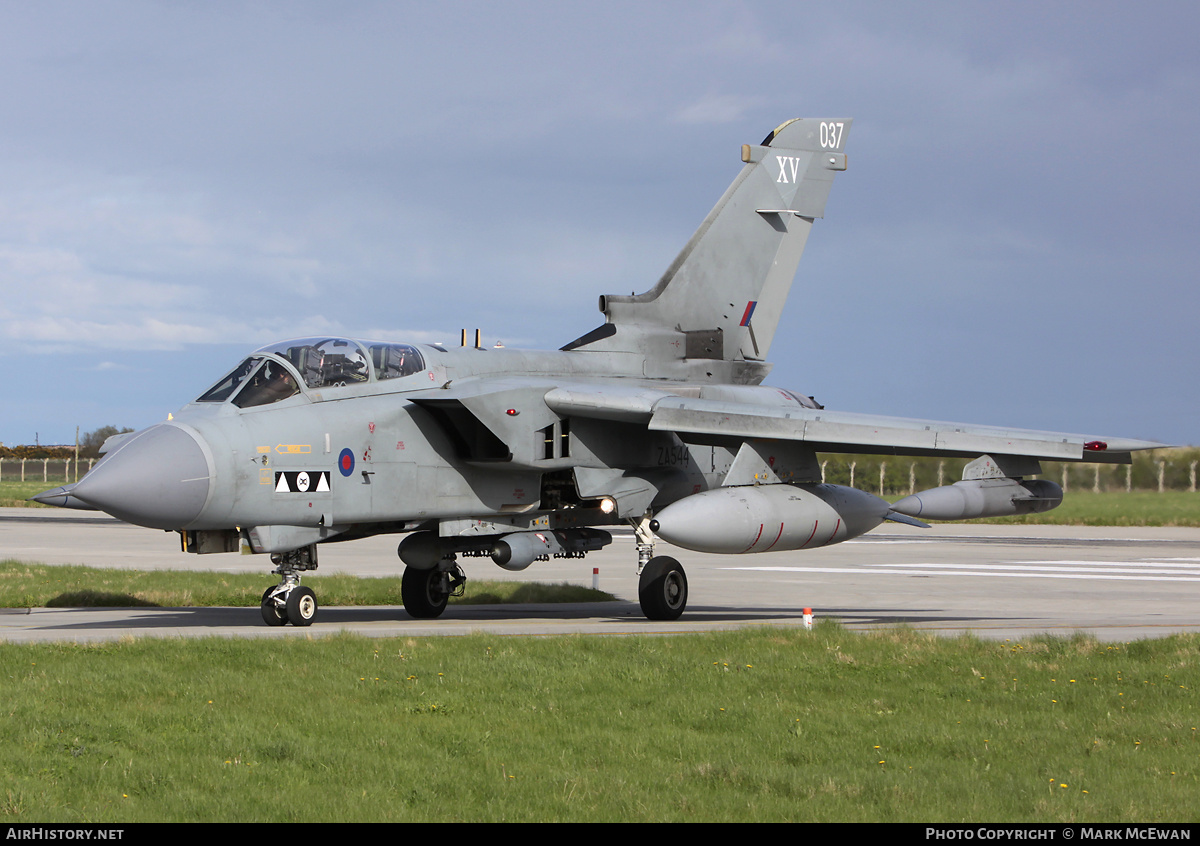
<box><xmin>564</xmin><ymin>119</ymin><xmax>851</xmax><ymax>361</ymax></box>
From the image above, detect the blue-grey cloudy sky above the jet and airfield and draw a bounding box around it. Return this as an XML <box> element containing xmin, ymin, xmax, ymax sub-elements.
<box><xmin>0</xmin><ymin>0</ymin><xmax>1200</xmax><ymax>444</ymax></box>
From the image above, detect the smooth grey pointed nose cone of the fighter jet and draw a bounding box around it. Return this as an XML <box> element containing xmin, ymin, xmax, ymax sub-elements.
<box><xmin>71</xmin><ymin>424</ymin><xmax>210</xmax><ymax>529</ymax></box>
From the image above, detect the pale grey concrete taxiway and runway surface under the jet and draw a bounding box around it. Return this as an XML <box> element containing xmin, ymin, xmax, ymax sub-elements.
<box><xmin>0</xmin><ymin>509</ymin><xmax>1200</xmax><ymax>642</ymax></box>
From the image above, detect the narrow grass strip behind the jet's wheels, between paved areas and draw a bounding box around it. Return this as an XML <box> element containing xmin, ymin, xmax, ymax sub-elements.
<box><xmin>0</xmin><ymin>559</ymin><xmax>614</xmax><ymax>608</ymax></box>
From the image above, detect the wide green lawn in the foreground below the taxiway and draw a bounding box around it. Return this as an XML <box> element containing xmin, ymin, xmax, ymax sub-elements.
<box><xmin>0</xmin><ymin>624</ymin><xmax>1200</xmax><ymax>823</ymax></box>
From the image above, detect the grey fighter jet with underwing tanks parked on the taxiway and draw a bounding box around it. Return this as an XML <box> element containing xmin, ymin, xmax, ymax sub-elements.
<box><xmin>34</xmin><ymin>119</ymin><xmax>1160</xmax><ymax>625</ymax></box>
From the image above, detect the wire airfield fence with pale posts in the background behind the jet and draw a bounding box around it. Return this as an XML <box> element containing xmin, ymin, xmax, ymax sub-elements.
<box><xmin>0</xmin><ymin>448</ymin><xmax>1200</xmax><ymax>496</ymax></box>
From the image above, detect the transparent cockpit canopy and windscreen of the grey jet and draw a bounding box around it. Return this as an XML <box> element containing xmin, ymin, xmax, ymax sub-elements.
<box><xmin>197</xmin><ymin>337</ymin><xmax>425</xmax><ymax>408</ymax></box>
